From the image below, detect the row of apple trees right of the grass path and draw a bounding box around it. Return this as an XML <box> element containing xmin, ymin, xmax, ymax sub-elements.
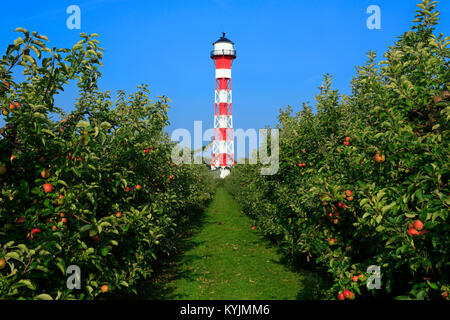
<box><xmin>227</xmin><ymin>0</ymin><xmax>450</xmax><ymax>299</ymax></box>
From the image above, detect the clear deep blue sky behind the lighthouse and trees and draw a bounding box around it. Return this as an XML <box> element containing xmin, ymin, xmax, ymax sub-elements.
<box><xmin>0</xmin><ymin>0</ymin><xmax>450</xmax><ymax>154</ymax></box>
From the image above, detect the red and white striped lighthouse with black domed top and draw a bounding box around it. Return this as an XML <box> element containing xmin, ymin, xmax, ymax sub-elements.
<box><xmin>211</xmin><ymin>32</ymin><xmax>236</xmax><ymax>178</ymax></box>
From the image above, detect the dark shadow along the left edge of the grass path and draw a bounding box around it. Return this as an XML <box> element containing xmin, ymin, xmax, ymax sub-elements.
<box><xmin>109</xmin><ymin>210</ymin><xmax>212</xmax><ymax>300</ymax></box>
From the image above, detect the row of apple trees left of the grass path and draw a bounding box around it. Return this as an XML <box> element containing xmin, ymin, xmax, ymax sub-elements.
<box><xmin>0</xmin><ymin>28</ymin><xmax>213</xmax><ymax>299</ymax></box>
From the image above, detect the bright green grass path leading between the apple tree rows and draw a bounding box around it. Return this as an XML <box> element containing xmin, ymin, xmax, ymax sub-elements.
<box><xmin>144</xmin><ymin>188</ymin><xmax>320</xmax><ymax>300</ymax></box>
